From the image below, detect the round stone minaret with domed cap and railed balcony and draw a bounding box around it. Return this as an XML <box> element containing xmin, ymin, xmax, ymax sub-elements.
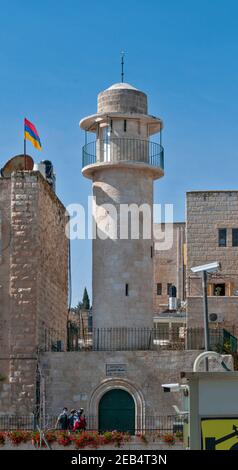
<box><xmin>80</xmin><ymin>83</ymin><xmax>164</xmax><ymax>338</ymax></box>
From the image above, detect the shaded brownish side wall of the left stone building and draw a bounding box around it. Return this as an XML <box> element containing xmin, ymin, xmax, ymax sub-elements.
<box><xmin>37</xmin><ymin>173</ymin><xmax>68</xmax><ymax>347</ymax></box>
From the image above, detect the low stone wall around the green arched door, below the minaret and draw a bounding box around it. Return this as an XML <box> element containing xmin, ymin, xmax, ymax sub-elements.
<box><xmin>41</xmin><ymin>351</ymin><xmax>199</xmax><ymax>420</ymax></box>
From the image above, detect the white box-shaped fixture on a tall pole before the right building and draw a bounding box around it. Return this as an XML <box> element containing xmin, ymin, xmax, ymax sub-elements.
<box><xmin>191</xmin><ymin>261</ymin><xmax>221</xmax><ymax>371</ymax></box>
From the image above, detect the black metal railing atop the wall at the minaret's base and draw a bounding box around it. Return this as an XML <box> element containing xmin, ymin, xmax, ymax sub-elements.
<box><xmin>40</xmin><ymin>322</ymin><xmax>237</xmax><ymax>353</ymax></box>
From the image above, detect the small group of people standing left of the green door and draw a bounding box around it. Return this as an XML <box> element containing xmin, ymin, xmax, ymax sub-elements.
<box><xmin>55</xmin><ymin>407</ymin><xmax>87</xmax><ymax>431</ymax></box>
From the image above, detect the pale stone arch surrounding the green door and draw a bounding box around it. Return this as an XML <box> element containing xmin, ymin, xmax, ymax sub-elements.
<box><xmin>88</xmin><ymin>378</ymin><xmax>145</xmax><ymax>430</ymax></box>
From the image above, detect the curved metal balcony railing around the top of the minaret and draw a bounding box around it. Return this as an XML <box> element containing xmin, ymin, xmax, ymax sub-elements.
<box><xmin>82</xmin><ymin>137</ymin><xmax>164</xmax><ymax>170</ymax></box>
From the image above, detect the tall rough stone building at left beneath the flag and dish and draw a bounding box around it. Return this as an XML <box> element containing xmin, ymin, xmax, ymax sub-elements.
<box><xmin>0</xmin><ymin>171</ymin><xmax>68</xmax><ymax>414</ymax></box>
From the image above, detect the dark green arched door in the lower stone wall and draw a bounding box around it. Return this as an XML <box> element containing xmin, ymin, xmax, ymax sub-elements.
<box><xmin>99</xmin><ymin>389</ymin><xmax>135</xmax><ymax>434</ymax></box>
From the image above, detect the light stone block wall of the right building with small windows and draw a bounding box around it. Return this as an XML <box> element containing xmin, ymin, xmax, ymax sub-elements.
<box><xmin>186</xmin><ymin>191</ymin><xmax>238</xmax><ymax>333</ymax></box>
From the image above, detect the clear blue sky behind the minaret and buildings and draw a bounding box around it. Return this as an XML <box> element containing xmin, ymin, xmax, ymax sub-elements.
<box><xmin>0</xmin><ymin>0</ymin><xmax>238</xmax><ymax>304</ymax></box>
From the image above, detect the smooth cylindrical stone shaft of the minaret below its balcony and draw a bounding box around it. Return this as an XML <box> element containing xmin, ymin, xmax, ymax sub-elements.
<box><xmin>93</xmin><ymin>168</ymin><xmax>153</xmax><ymax>328</ymax></box>
